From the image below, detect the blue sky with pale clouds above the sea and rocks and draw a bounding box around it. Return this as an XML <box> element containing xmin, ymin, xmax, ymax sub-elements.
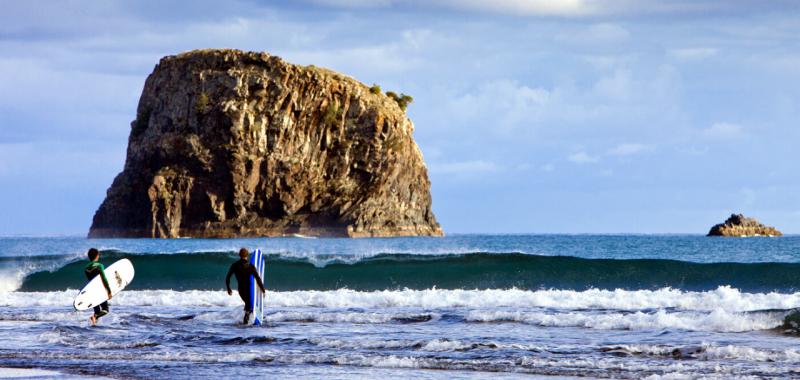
<box><xmin>0</xmin><ymin>0</ymin><xmax>800</xmax><ymax>236</ymax></box>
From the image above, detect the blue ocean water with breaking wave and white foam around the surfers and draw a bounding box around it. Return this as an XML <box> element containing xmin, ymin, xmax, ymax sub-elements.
<box><xmin>0</xmin><ymin>235</ymin><xmax>800</xmax><ymax>379</ymax></box>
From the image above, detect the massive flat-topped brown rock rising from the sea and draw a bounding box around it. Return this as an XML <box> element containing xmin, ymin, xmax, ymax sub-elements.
<box><xmin>89</xmin><ymin>50</ymin><xmax>442</xmax><ymax>238</ymax></box>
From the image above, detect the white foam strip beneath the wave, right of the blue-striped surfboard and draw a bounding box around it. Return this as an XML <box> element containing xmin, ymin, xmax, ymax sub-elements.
<box><xmin>268</xmin><ymin>286</ymin><xmax>800</xmax><ymax>311</ymax></box>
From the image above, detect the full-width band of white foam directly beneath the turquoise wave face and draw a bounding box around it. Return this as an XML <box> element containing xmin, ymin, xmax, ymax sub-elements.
<box><xmin>0</xmin><ymin>286</ymin><xmax>800</xmax><ymax>312</ymax></box>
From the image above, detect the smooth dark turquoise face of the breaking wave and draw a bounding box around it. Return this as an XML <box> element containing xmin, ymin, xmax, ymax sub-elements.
<box><xmin>19</xmin><ymin>251</ymin><xmax>800</xmax><ymax>292</ymax></box>
